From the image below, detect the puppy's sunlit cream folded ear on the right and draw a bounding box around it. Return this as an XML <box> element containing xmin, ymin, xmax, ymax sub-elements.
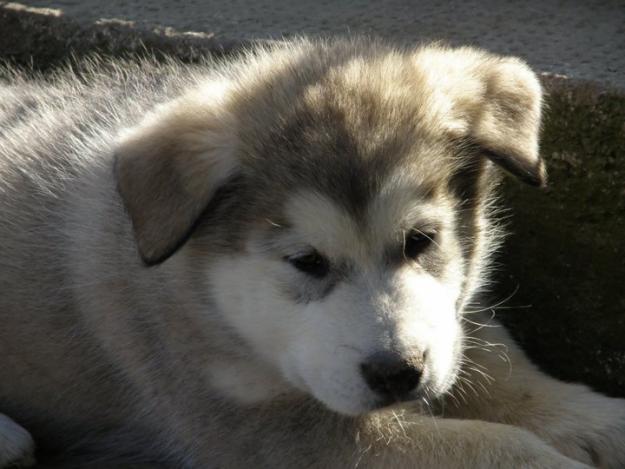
<box><xmin>421</xmin><ymin>48</ymin><xmax>547</xmax><ymax>186</ymax></box>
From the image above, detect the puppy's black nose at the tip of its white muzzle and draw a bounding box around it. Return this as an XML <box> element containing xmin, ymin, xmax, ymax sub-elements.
<box><xmin>360</xmin><ymin>352</ymin><xmax>423</xmax><ymax>401</ymax></box>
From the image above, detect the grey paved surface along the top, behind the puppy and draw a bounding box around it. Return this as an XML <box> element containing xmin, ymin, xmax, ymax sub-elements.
<box><xmin>22</xmin><ymin>0</ymin><xmax>625</xmax><ymax>89</ymax></box>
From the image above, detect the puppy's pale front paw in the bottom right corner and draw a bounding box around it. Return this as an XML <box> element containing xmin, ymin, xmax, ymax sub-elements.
<box><xmin>544</xmin><ymin>391</ymin><xmax>625</xmax><ymax>469</ymax></box>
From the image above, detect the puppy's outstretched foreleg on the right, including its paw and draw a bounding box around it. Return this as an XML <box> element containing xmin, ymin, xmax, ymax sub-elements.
<box><xmin>445</xmin><ymin>317</ymin><xmax>625</xmax><ymax>468</ymax></box>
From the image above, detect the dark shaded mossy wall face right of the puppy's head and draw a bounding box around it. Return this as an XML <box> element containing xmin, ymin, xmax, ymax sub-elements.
<box><xmin>498</xmin><ymin>83</ymin><xmax>625</xmax><ymax>396</ymax></box>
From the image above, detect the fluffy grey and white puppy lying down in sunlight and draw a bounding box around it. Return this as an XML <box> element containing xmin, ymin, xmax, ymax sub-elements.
<box><xmin>0</xmin><ymin>40</ymin><xmax>625</xmax><ymax>469</ymax></box>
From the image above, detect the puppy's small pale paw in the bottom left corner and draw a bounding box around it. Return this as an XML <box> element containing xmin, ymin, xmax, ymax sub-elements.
<box><xmin>0</xmin><ymin>414</ymin><xmax>35</xmax><ymax>469</ymax></box>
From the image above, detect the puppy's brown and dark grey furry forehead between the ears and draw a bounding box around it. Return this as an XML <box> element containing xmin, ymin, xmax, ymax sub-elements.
<box><xmin>237</xmin><ymin>44</ymin><xmax>464</xmax><ymax>242</ymax></box>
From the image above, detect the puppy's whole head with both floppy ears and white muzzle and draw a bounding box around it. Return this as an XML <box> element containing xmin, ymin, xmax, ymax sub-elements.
<box><xmin>116</xmin><ymin>41</ymin><xmax>544</xmax><ymax>415</ymax></box>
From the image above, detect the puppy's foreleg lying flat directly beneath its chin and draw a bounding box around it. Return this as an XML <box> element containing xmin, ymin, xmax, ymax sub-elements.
<box><xmin>191</xmin><ymin>399</ymin><xmax>590</xmax><ymax>469</ymax></box>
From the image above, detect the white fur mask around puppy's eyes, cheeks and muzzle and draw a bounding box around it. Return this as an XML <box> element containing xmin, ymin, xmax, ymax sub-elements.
<box><xmin>209</xmin><ymin>186</ymin><xmax>462</xmax><ymax>414</ymax></box>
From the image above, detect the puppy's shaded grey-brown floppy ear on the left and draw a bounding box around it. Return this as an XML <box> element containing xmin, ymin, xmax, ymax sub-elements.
<box><xmin>115</xmin><ymin>84</ymin><xmax>237</xmax><ymax>265</ymax></box>
